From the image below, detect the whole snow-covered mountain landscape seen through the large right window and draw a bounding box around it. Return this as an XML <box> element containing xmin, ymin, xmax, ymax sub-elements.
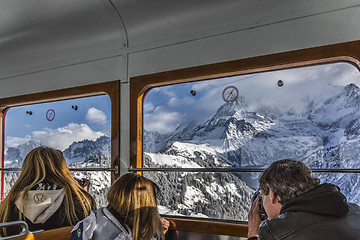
<box><xmin>144</xmin><ymin>84</ymin><xmax>360</xmax><ymax>220</ymax></box>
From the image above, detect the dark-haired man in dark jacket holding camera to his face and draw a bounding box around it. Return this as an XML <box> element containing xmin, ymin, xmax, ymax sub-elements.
<box><xmin>248</xmin><ymin>159</ymin><xmax>360</xmax><ymax>240</ymax></box>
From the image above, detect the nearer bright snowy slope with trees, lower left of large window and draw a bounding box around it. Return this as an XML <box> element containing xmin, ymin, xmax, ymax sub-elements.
<box><xmin>144</xmin><ymin>142</ymin><xmax>253</xmax><ymax>220</ymax></box>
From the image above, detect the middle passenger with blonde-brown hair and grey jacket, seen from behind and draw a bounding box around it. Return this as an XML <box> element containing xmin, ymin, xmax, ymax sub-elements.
<box><xmin>71</xmin><ymin>173</ymin><xmax>169</xmax><ymax>240</ymax></box>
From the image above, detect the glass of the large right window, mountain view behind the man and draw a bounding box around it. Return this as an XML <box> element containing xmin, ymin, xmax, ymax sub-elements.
<box><xmin>143</xmin><ymin>62</ymin><xmax>360</xmax><ymax>221</ymax></box>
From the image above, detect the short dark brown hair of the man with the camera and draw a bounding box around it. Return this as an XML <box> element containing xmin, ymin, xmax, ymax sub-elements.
<box><xmin>259</xmin><ymin>159</ymin><xmax>320</xmax><ymax>204</ymax></box>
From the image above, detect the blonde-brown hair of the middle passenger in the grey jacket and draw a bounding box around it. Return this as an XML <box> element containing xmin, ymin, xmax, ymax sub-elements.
<box><xmin>107</xmin><ymin>173</ymin><xmax>164</xmax><ymax>240</ymax></box>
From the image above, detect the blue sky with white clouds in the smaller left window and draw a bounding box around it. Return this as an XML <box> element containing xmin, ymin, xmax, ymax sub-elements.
<box><xmin>5</xmin><ymin>95</ymin><xmax>111</xmax><ymax>150</ymax></box>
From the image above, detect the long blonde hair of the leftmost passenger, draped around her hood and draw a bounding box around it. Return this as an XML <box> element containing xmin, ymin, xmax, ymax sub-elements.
<box><xmin>0</xmin><ymin>147</ymin><xmax>95</xmax><ymax>229</ymax></box>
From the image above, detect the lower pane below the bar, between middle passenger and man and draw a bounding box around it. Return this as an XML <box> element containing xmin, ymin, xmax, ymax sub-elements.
<box><xmin>144</xmin><ymin>172</ymin><xmax>258</xmax><ymax>221</ymax></box>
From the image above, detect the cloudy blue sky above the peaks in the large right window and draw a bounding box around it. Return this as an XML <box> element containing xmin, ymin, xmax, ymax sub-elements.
<box><xmin>143</xmin><ymin>62</ymin><xmax>360</xmax><ymax>133</ymax></box>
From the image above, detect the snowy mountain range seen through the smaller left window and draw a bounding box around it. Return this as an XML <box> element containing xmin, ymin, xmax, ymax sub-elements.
<box><xmin>4</xmin><ymin>135</ymin><xmax>111</xmax><ymax>206</ymax></box>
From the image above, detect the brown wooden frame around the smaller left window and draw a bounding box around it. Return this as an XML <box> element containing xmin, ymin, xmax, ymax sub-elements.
<box><xmin>0</xmin><ymin>81</ymin><xmax>120</xmax><ymax>182</ymax></box>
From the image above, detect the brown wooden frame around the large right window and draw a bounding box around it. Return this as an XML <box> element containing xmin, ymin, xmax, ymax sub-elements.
<box><xmin>130</xmin><ymin>40</ymin><xmax>360</xmax><ymax>237</ymax></box>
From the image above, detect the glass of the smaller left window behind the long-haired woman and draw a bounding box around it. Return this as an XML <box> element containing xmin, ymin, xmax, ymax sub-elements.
<box><xmin>2</xmin><ymin>95</ymin><xmax>111</xmax><ymax>206</ymax></box>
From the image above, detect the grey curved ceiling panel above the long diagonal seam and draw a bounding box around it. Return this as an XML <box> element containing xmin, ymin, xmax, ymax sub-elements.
<box><xmin>0</xmin><ymin>0</ymin><xmax>359</xmax><ymax>79</ymax></box>
